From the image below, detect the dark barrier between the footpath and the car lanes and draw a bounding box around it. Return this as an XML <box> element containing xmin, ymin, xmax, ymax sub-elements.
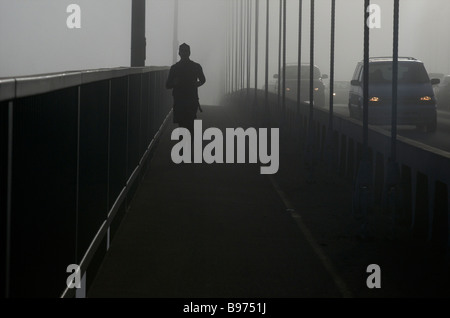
<box><xmin>229</xmin><ymin>90</ymin><xmax>450</xmax><ymax>255</ymax></box>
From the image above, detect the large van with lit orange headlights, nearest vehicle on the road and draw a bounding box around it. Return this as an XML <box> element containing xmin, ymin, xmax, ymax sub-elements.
<box><xmin>348</xmin><ymin>57</ymin><xmax>440</xmax><ymax>132</ymax></box>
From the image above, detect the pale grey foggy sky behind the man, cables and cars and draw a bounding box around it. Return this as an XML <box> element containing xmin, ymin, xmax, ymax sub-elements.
<box><xmin>0</xmin><ymin>0</ymin><xmax>450</xmax><ymax>105</ymax></box>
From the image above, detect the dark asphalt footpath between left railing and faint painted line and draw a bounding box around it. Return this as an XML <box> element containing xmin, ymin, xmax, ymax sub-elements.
<box><xmin>88</xmin><ymin>107</ymin><xmax>342</xmax><ymax>298</ymax></box>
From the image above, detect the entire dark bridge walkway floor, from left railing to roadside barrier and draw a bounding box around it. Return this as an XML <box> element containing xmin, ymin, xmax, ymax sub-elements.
<box><xmin>87</xmin><ymin>102</ymin><xmax>448</xmax><ymax>298</ymax></box>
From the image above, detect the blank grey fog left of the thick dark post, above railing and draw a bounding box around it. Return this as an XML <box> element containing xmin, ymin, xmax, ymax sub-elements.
<box><xmin>0</xmin><ymin>0</ymin><xmax>131</xmax><ymax>77</ymax></box>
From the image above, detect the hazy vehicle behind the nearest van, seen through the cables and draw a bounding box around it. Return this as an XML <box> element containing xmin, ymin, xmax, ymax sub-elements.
<box><xmin>273</xmin><ymin>63</ymin><xmax>328</xmax><ymax>107</ymax></box>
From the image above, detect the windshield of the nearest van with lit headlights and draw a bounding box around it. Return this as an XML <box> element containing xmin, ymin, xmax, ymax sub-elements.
<box><xmin>369</xmin><ymin>62</ymin><xmax>430</xmax><ymax>84</ymax></box>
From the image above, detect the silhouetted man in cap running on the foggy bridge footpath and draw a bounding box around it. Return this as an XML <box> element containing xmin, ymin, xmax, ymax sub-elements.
<box><xmin>166</xmin><ymin>43</ymin><xmax>206</xmax><ymax>136</ymax></box>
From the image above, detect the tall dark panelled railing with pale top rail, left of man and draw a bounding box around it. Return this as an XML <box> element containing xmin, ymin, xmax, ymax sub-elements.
<box><xmin>0</xmin><ymin>67</ymin><xmax>172</xmax><ymax>297</ymax></box>
